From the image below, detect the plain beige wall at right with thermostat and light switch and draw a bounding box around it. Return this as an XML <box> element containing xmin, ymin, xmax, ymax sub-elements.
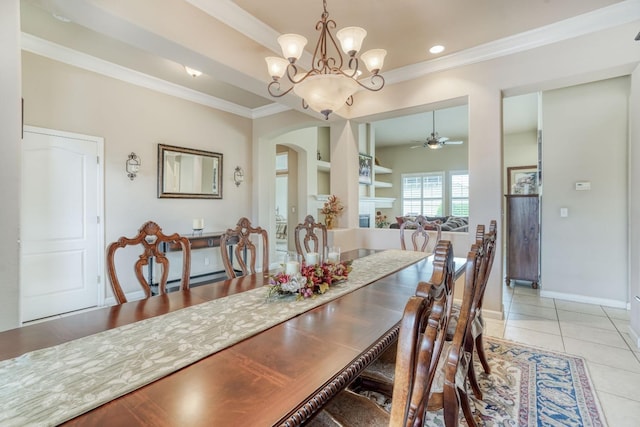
<box><xmin>541</xmin><ymin>77</ymin><xmax>630</xmax><ymax>307</ymax></box>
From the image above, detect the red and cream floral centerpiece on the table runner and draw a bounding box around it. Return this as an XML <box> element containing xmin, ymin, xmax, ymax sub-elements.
<box><xmin>269</xmin><ymin>261</ymin><xmax>351</xmax><ymax>299</ymax></box>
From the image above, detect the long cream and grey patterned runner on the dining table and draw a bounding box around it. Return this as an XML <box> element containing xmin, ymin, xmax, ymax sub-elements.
<box><xmin>0</xmin><ymin>250</ymin><xmax>426</xmax><ymax>426</ymax></box>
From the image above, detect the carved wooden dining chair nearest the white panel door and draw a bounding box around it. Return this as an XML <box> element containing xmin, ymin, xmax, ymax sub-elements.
<box><xmin>107</xmin><ymin>221</ymin><xmax>191</xmax><ymax>304</ymax></box>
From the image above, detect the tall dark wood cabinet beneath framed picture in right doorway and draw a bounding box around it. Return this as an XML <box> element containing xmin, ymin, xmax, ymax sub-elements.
<box><xmin>505</xmin><ymin>194</ymin><xmax>540</xmax><ymax>289</ymax></box>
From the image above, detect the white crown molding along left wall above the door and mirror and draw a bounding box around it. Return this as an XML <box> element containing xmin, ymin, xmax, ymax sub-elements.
<box><xmin>21</xmin><ymin>32</ymin><xmax>258</xmax><ymax>119</ymax></box>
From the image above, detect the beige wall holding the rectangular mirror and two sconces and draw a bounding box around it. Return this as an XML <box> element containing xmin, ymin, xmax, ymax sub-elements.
<box><xmin>22</xmin><ymin>52</ymin><xmax>252</xmax><ymax>304</ymax></box>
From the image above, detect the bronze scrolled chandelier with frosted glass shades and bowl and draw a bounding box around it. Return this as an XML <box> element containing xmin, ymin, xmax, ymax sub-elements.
<box><xmin>265</xmin><ymin>0</ymin><xmax>387</xmax><ymax>119</ymax></box>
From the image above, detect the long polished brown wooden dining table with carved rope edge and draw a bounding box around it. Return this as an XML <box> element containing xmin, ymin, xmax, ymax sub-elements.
<box><xmin>0</xmin><ymin>249</ymin><xmax>466</xmax><ymax>426</ymax></box>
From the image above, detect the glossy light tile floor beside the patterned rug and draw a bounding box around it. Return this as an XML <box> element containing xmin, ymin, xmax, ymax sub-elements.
<box><xmin>486</xmin><ymin>284</ymin><xmax>640</xmax><ymax>427</ymax></box>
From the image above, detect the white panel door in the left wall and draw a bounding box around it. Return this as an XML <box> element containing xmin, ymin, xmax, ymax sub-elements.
<box><xmin>20</xmin><ymin>128</ymin><xmax>103</xmax><ymax>322</ymax></box>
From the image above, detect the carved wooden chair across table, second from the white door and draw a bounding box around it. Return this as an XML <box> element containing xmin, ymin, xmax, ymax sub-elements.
<box><xmin>220</xmin><ymin>217</ymin><xmax>269</xmax><ymax>279</ymax></box>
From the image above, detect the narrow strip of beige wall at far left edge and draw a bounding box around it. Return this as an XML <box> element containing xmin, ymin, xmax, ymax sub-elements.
<box><xmin>0</xmin><ymin>0</ymin><xmax>21</xmax><ymax>331</ymax></box>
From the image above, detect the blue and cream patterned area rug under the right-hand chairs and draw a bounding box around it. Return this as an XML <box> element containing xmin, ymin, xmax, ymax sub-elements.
<box><xmin>363</xmin><ymin>338</ymin><xmax>607</xmax><ymax>427</ymax></box>
